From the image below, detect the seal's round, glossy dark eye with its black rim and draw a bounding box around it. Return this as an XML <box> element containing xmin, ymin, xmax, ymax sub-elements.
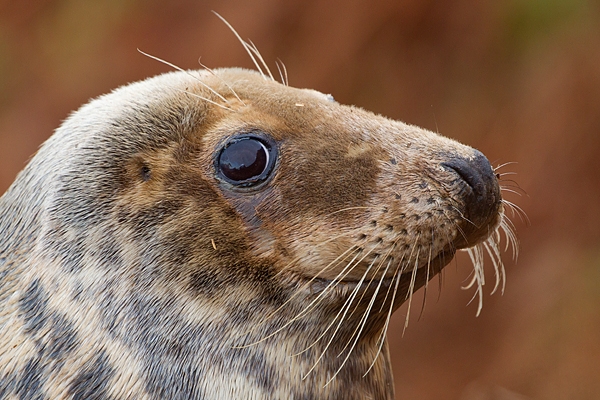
<box><xmin>216</xmin><ymin>136</ymin><xmax>275</xmax><ymax>187</ymax></box>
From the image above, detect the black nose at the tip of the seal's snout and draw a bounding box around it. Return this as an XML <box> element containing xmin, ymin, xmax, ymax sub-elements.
<box><xmin>441</xmin><ymin>150</ymin><xmax>502</xmax><ymax>245</ymax></box>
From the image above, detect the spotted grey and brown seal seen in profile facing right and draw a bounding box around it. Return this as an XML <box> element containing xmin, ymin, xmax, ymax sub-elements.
<box><xmin>0</xmin><ymin>50</ymin><xmax>513</xmax><ymax>399</ymax></box>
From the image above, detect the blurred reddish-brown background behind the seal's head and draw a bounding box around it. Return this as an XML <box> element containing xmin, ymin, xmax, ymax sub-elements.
<box><xmin>0</xmin><ymin>0</ymin><xmax>600</xmax><ymax>400</ymax></box>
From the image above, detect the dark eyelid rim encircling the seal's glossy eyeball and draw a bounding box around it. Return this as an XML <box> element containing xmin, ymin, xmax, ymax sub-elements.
<box><xmin>213</xmin><ymin>129</ymin><xmax>279</xmax><ymax>192</ymax></box>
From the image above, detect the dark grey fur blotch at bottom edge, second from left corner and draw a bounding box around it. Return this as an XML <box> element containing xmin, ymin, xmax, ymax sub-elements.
<box><xmin>68</xmin><ymin>352</ymin><xmax>115</xmax><ymax>400</ymax></box>
